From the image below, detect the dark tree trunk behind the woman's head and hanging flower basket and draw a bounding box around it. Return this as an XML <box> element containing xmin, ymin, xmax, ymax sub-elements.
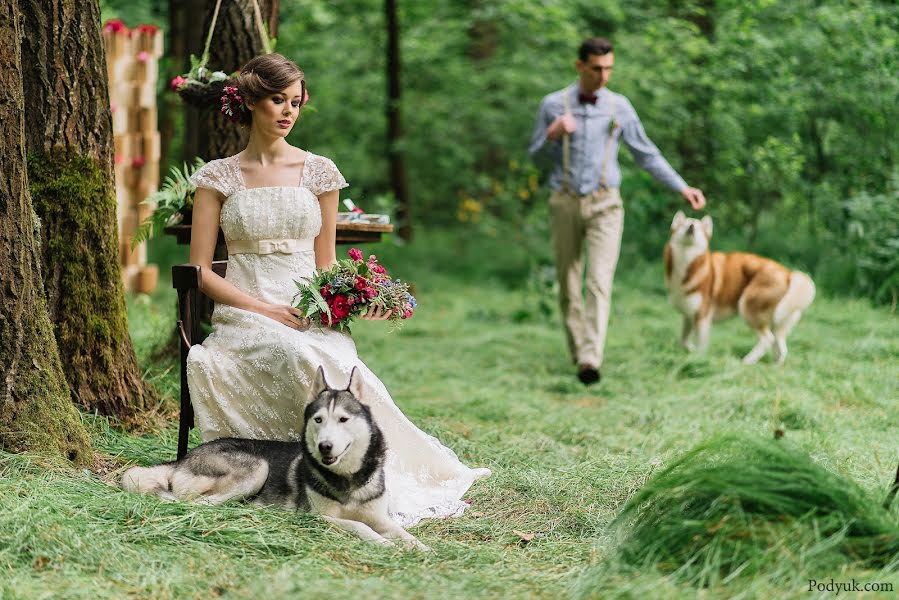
<box><xmin>194</xmin><ymin>0</ymin><xmax>280</xmax><ymax>160</ymax></box>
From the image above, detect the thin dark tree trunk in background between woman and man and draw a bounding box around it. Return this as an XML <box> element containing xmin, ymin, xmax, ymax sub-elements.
<box><xmin>384</xmin><ymin>0</ymin><xmax>412</xmax><ymax>241</ymax></box>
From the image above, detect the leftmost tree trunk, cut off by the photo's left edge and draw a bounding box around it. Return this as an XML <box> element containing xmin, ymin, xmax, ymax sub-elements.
<box><xmin>0</xmin><ymin>2</ymin><xmax>91</xmax><ymax>465</ymax></box>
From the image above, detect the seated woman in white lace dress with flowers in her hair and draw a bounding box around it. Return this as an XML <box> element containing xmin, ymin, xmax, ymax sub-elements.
<box><xmin>187</xmin><ymin>54</ymin><xmax>490</xmax><ymax>526</ymax></box>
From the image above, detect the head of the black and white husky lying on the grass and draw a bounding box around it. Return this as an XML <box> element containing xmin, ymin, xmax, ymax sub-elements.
<box><xmin>304</xmin><ymin>367</ymin><xmax>373</xmax><ymax>475</ymax></box>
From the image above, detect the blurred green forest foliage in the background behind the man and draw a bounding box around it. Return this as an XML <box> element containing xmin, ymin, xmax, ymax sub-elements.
<box><xmin>270</xmin><ymin>0</ymin><xmax>899</xmax><ymax>301</ymax></box>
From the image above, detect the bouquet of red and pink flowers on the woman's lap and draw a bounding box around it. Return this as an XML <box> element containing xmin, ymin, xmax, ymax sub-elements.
<box><xmin>294</xmin><ymin>248</ymin><xmax>417</xmax><ymax>331</ymax></box>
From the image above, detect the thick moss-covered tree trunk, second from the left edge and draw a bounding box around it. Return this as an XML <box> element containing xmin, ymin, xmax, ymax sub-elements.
<box><xmin>19</xmin><ymin>0</ymin><xmax>153</xmax><ymax>422</ymax></box>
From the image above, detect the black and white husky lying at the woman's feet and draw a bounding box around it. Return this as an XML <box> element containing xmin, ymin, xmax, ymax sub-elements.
<box><xmin>121</xmin><ymin>367</ymin><xmax>428</xmax><ymax>550</ymax></box>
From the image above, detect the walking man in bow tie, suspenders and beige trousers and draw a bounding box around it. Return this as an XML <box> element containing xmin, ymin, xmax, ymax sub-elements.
<box><xmin>528</xmin><ymin>38</ymin><xmax>705</xmax><ymax>385</ymax></box>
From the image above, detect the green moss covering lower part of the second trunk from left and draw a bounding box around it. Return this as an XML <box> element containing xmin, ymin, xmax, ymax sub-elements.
<box><xmin>28</xmin><ymin>152</ymin><xmax>152</xmax><ymax>422</ymax></box>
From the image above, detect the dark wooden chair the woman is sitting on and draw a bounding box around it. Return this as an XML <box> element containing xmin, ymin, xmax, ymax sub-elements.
<box><xmin>172</xmin><ymin>260</ymin><xmax>228</xmax><ymax>459</ymax></box>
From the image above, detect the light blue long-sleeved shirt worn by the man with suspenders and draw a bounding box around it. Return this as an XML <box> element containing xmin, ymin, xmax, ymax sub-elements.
<box><xmin>528</xmin><ymin>83</ymin><xmax>687</xmax><ymax>195</ymax></box>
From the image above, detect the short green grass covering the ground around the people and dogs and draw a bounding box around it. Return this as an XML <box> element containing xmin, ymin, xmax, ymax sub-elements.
<box><xmin>0</xmin><ymin>232</ymin><xmax>899</xmax><ymax>598</ymax></box>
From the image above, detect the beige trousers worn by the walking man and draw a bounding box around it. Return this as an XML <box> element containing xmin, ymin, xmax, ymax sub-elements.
<box><xmin>549</xmin><ymin>188</ymin><xmax>624</xmax><ymax>367</ymax></box>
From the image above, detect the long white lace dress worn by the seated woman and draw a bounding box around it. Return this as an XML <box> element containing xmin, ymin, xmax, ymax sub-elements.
<box><xmin>187</xmin><ymin>153</ymin><xmax>490</xmax><ymax>526</ymax></box>
